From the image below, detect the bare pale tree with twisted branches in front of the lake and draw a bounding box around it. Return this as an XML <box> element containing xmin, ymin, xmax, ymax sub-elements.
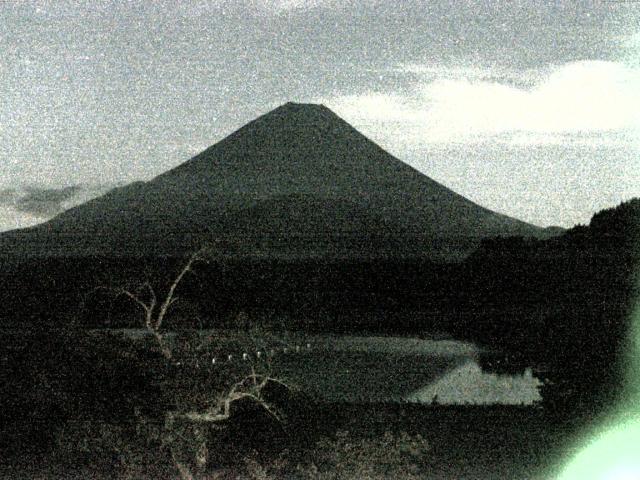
<box><xmin>102</xmin><ymin>247</ymin><xmax>288</xmax><ymax>480</ymax></box>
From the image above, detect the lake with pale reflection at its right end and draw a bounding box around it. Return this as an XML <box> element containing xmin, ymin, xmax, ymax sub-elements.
<box><xmin>102</xmin><ymin>330</ymin><xmax>542</xmax><ymax>405</ymax></box>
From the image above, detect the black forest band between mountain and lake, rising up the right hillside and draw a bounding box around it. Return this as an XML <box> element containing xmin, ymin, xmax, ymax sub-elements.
<box><xmin>0</xmin><ymin>199</ymin><xmax>640</xmax><ymax>416</ymax></box>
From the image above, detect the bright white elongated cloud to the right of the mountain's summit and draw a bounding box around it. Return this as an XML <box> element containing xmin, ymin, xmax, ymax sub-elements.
<box><xmin>325</xmin><ymin>61</ymin><xmax>640</xmax><ymax>143</ymax></box>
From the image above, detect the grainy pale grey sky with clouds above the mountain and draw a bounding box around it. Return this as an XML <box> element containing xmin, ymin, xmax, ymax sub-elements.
<box><xmin>0</xmin><ymin>0</ymin><xmax>640</xmax><ymax>230</ymax></box>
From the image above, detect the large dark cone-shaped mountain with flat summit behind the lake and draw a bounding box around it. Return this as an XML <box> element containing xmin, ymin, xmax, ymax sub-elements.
<box><xmin>0</xmin><ymin>103</ymin><xmax>544</xmax><ymax>258</ymax></box>
